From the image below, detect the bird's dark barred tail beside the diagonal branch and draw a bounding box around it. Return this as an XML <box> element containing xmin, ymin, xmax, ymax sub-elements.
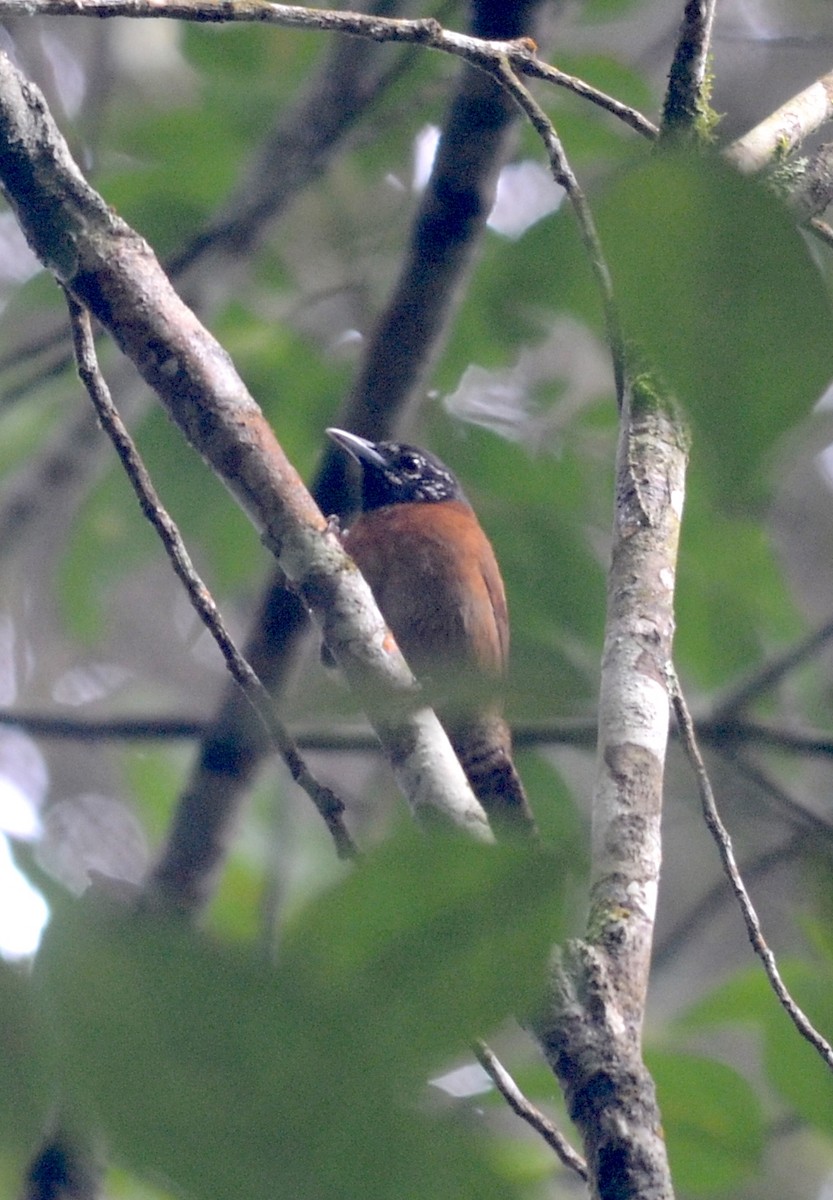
<box><xmin>448</xmin><ymin>713</ymin><xmax>538</xmax><ymax>838</ymax></box>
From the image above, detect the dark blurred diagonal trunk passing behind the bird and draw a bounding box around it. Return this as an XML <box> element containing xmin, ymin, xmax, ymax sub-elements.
<box><xmin>158</xmin><ymin>0</ymin><xmax>554</xmax><ymax>899</ymax></box>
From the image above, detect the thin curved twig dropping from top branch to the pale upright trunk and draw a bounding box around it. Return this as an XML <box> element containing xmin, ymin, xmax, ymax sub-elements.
<box><xmin>489</xmin><ymin>55</ymin><xmax>625</xmax><ymax>409</ymax></box>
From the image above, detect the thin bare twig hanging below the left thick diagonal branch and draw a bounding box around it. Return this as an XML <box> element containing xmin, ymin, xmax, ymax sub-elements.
<box><xmin>66</xmin><ymin>292</ymin><xmax>356</xmax><ymax>858</ymax></box>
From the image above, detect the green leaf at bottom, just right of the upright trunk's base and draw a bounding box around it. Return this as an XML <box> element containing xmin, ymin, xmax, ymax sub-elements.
<box><xmin>646</xmin><ymin>1050</ymin><xmax>766</xmax><ymax>1195</ymax></box>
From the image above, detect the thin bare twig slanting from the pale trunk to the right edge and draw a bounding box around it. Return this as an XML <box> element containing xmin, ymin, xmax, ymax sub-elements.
<box><xmin>667</xmin><ymin>664</ymin><xmax>833</xmax><ymax>1070</ymax></box>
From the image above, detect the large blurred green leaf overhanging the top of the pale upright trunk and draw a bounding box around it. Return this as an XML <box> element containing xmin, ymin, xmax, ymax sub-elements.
<box><xmin>598</xmin><ymin>155</ymin><xmax>833</xmax><ymax>509</ymax></box>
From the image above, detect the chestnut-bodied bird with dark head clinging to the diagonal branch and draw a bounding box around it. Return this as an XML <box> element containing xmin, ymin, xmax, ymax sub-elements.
<box><xmin>326</xmin><ymin>428</ymin><xmax>538</xmax><ymax>838</ymax></box>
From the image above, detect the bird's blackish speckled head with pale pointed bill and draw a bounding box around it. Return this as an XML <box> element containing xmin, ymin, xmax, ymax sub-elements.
<box><xmin>326</xmin><ymin>430</ymin><xmax>466</xmax><ymax>511</ymax></box>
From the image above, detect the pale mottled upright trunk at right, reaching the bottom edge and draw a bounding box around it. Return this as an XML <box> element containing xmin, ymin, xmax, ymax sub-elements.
<box><xmin>537</xmin><ymin>378</ymin><xmax>687</xmax><ymax>1200</ymax></box>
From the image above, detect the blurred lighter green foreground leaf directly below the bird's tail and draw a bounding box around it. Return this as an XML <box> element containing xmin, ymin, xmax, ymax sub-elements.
<box><xmin>282</xmin><ymin>829</ymin><xmax>564</xmax><ymax>1072</ymax></box>
